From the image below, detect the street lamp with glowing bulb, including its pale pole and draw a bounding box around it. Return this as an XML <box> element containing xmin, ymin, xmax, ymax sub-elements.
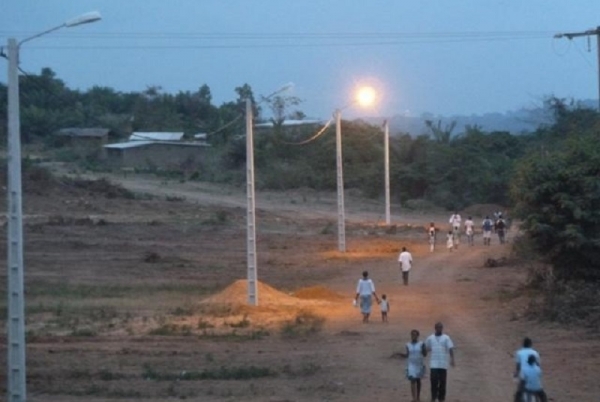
<box><xmin>334</xmin><ymin>87</ymin><xmax>375</xmax><ymax>253</ymax></box>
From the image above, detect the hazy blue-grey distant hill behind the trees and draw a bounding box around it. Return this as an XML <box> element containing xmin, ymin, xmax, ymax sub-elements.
<box><xmin>363</xmin><ymin>100</ymin><xmax>598</xmax><ymax>136</ymax></box>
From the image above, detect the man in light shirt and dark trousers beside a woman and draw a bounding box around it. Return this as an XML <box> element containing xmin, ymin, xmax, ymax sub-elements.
<box><xmin>425</xmin><ymin>322</ymin><xmax>455</xmax><ymax>402</ymax></box>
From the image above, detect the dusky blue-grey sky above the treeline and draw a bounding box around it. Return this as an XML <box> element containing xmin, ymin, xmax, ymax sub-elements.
<box><xmin>0</xmin><ymin>0</ymin><xmax>600</xmax><ymax>118</ymax></box>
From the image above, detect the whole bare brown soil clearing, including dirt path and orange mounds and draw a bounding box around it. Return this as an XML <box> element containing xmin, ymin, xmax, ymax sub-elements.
<box><xmin>0</xmin><ymin>168</ymin><xmax>600</xmax><ymax>402</ymax></box>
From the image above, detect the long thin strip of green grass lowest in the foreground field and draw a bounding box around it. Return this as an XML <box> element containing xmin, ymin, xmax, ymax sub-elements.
<box><xmin>142</xmin><ymin>365</ymin><xmax>278</xmax><ymax>381</ymax></box>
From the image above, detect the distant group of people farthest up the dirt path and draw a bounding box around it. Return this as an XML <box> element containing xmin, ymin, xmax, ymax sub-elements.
<box><xmin>427</xmin><ymin>212</ymin><xmax>507</xmax><ymax>252</ymax></box>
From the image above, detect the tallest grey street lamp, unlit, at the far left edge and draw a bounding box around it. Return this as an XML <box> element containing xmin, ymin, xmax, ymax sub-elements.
<box><xmin>6</xmin><ymin>11</ymin><xmax>101</xmax><ymax>402</ymax></box>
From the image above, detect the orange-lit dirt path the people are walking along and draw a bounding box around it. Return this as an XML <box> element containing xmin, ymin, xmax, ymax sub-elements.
<box><xmin>316</xmin><ymin>240</ymin><xmax>515</xmax><ymax>402</ymax></box>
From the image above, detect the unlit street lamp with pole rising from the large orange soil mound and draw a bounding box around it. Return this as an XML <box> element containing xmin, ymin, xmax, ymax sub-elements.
<box><xmin>246</xmin><ymin>83</ymin><xmax>294</xmax><ymax>306</ymax></box>
